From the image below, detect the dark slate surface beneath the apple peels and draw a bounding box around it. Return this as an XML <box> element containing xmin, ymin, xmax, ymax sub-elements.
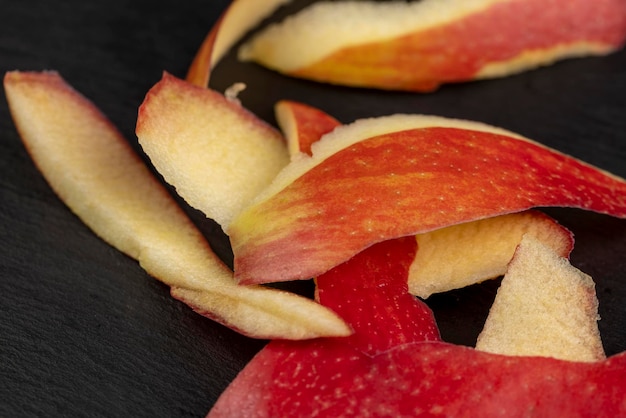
<box><xmin>0</xmin><ymin>0</ymin><xmax>626</xmax><ymax>417</ymax></box>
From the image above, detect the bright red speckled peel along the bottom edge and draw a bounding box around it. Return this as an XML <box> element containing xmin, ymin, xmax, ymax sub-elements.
<box><xmin>207</xmin><ymin>340</ymin><xmax>626</xmax><ymax>418</ymax></box>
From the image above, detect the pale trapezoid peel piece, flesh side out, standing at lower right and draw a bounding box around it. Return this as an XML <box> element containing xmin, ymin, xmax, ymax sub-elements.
<box><xmin>476</xmin><ymin>235</ymin><xmax>606</xmax><ymax>362</ymax></box>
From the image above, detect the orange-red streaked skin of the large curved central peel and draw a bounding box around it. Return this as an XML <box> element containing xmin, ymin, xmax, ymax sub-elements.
<box><xmin>228</xmin><ymin>128</ymin><xmax>626</xmax><ymax>283</ymax></box>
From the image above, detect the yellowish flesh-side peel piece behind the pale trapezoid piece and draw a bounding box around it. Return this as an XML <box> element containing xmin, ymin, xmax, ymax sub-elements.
<box><xmin>409</xmin><ymin>210</ymin><xmax>574</xmax><ymax>299</ymax></box>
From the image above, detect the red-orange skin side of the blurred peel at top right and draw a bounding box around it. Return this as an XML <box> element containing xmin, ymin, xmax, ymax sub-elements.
<box><xmin>290</xmin><ymin>0</ymin><xmax>626</xmax><ymax>91</ymax></box>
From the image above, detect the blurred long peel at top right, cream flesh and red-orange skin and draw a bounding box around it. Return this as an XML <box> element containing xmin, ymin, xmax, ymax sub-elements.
<box><xmin>239</xmin><ymin>0</ymin><xmax>626</xmax><ymax>92</ymax></box>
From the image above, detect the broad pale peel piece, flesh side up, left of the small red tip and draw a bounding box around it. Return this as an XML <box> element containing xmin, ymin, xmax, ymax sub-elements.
<box><xmin>136</xmin><ymin>73</ymin><xmax>289</xmax><ymax>228</ymax></box>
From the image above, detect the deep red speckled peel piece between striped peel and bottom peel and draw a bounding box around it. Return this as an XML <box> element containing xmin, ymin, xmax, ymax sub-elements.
<box><xmin>316</xmin><ymin>237</ymin><xmax>441</xmax><ymax>356</ymax></box>
